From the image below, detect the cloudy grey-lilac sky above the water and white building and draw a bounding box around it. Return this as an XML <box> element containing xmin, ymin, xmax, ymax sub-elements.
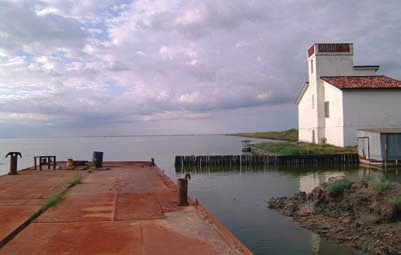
<box><xmin>0</xmin><ymin>0</ymin><xmax>401</xmax><ymax>137</ymax></box>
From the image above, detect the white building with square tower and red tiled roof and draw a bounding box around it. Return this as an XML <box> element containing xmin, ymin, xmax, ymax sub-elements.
<box><xmin>296</xmin><ymin>43</ymin><xmax>401</xmax><ymax>146</ymax></box>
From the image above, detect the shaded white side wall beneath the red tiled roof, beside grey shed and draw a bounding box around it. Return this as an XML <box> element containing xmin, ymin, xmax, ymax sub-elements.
<box><xmin>343</xmin><ymin>89</ymin><xmax>401</xmax><ymax>146</ymax></box>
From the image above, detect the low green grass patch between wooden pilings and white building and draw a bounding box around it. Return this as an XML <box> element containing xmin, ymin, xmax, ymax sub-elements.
<box><xmin>255</xmin><ymin>142</ymin><xmax>357</xmax><ymax>155</ymax></box>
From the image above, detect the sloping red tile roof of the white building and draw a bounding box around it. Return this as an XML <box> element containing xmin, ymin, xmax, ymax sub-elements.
<box><xmin>320</xmin><ymin>75</ymin><xmax>401</xmax><ymax>89</ymax></box>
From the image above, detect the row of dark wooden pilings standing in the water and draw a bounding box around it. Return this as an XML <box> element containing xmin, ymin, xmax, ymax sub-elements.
<box><xmin>174</xmin><ymin>154</ymin><xmax>359</xmax><ymax>167</ymax></box>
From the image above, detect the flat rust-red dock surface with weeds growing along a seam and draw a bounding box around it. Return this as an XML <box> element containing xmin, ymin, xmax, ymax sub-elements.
<box><xmin>0</xmin><ymin>162</ymin><xmax>252</xmax><ymax>255</ymax></box>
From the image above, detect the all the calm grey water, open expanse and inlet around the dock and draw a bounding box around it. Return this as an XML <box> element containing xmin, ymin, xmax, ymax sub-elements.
<box><xmin>0</xmin><ymin>135</ymin><xmax>399</xmax><ymax>255</ymax></box>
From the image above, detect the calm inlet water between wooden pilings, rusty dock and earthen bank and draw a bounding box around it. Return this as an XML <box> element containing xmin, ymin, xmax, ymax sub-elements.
<box><xmin>175</xmin><ymin>166</ymin><xmax>400</xmax><ymax>255</ymax></box>
